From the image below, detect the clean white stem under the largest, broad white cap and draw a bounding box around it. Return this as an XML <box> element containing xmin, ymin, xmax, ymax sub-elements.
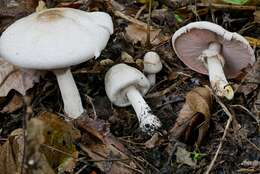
<box><xmin>53</xmin><ymin>69</ymin><xmax>84</xmax><ymax>119</ymax></box>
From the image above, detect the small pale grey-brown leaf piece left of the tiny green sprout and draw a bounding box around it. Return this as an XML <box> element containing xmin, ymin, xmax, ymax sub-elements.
<box><xmin>175</xmin><ymin>147</ymin><xmax>197</xmax><ymax>167</ymax></box>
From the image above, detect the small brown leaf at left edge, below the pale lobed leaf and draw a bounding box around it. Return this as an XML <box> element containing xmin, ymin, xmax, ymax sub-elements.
<box><xmin>0</xmin><ymin>94</ymin><xmax>23</xmax><ymax>113</ymax></box>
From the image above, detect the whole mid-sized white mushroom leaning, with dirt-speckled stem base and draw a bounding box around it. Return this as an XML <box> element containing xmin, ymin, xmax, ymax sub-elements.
<box><xmin>105</xmin><ymin>64</ymin><xmax>161</xmax><ymax>135</ymax></box>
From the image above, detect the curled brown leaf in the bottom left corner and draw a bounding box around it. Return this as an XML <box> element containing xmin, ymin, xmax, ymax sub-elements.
<box><xmin>0</xmin><ymin>129</ymin><xmax>24</xmax><ymax>174</ymax></box>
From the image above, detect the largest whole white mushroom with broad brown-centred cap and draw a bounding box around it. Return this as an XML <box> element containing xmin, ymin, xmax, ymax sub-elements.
<box><xmin>0</xmin><ymin>8</ymin><xmax>113</xmax><ymax>118</ymax></box>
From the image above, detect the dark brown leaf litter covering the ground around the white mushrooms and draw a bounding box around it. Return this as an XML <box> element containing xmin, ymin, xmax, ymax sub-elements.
<box><xmin>0</xmin><ymin>0</ymin><xmax>260</xmax><ymax>174</ymax></box>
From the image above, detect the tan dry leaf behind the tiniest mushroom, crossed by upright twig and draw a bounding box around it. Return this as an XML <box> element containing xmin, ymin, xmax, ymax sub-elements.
<box><xmin>125</xmin><ymin>24</ymin><xmax>161</xmax><ymax>45</ymax></box>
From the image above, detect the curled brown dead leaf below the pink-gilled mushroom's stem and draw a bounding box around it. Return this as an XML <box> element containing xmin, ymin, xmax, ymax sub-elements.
<box><xmin>169</xmin><ymin>87</ymin><xmax>213</xmax><ymax>145</ymax></box>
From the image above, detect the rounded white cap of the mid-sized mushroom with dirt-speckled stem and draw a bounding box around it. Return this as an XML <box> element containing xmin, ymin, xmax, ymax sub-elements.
<box><xmin>105</xmin><ymin>63</ymin><xmax>150</xmax><ymax>107</ymax></box>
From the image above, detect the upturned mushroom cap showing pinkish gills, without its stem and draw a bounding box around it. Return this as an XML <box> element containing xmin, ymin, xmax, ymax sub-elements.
<box><xmin>172</xmin><ymin>21</ymin><xmax>255</xmax><ymax>78</ymax></box>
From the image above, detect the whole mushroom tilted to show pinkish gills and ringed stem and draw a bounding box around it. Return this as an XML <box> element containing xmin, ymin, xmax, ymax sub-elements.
<box><xmin>172</xmin><ymin>21</ymin><xmax>255</xmax><ymax>100</ymax></box>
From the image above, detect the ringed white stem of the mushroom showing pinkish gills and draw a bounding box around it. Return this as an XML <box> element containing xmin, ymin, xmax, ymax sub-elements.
<box><xmin>204</xmin><ymin>42</ymin><xmax>234</xmax><ymax>100</ymax></box>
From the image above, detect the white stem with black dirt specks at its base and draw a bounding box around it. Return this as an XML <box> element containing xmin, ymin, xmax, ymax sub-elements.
<box><xmin>126</xmin><ymin>86</ymin><xmax>161</xmax><ymax>134</ymax></box>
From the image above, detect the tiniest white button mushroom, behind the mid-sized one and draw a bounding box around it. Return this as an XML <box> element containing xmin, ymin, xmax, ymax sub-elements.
<box><xmin>144</xmin><ymin>51</ymin><xmax>162</xmax><ymax>86</ymax></box>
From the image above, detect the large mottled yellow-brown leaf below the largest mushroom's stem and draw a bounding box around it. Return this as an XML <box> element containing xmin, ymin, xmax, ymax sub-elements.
<box><xmin>38</xmin><ymin>112</ymin><xmax>80</xmax><ymax>171</ymax></box>
